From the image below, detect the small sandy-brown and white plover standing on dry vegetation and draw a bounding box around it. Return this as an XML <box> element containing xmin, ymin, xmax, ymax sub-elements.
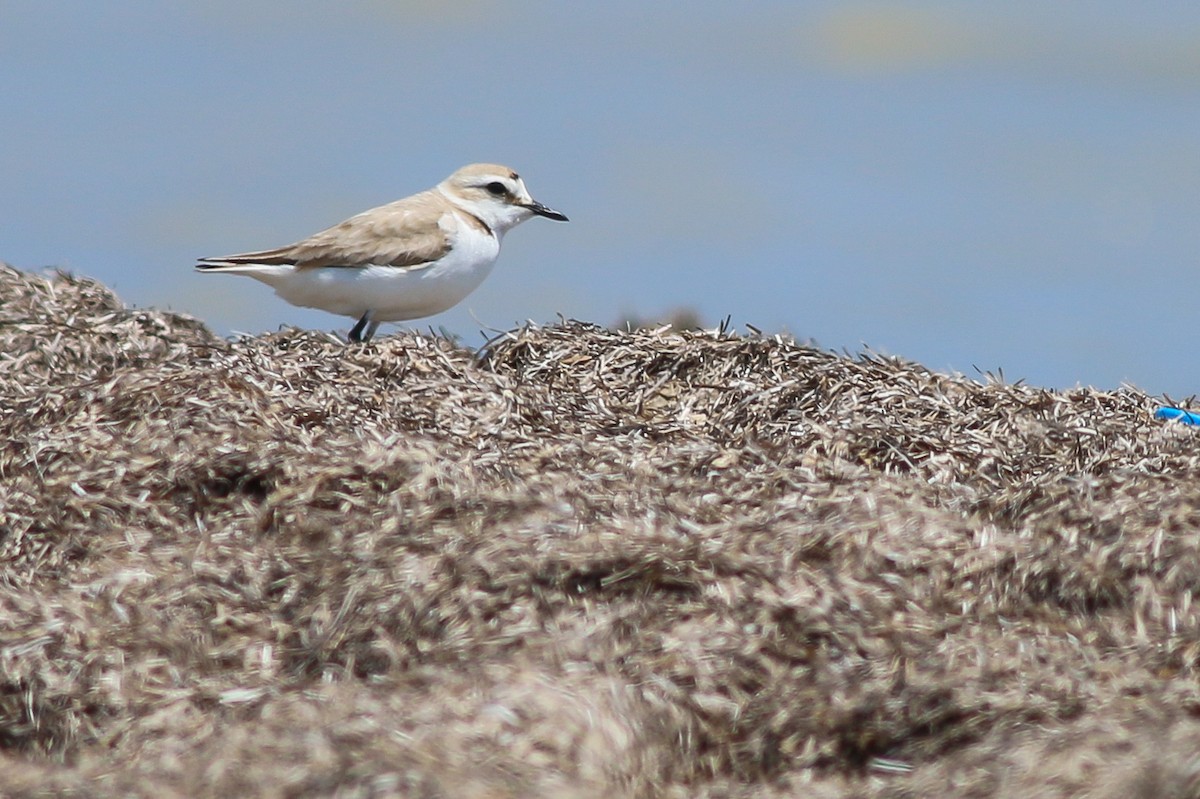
<box><xmin>196</xmin><ymin>163</ymin><xmax>568</xmax><ymax>342</ymax></box>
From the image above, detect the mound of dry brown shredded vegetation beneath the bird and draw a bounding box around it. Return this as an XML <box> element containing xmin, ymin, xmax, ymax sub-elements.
<box><xmin>0</xmin><ymin>266</ymin><xmax>1200</xmax><ymax>799</ymax></box>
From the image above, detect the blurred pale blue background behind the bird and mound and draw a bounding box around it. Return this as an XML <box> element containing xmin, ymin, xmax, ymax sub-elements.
<box><xmin>0</xmin><ymin>0</ymin><xmax>1200</xmax><ymax>397</ymax></box>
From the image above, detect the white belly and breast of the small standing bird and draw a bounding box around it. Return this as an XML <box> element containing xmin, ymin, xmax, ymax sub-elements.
<box><xmin>239</xmin><ymin>229</ymin><xmax>500</xmax><ymax>322</ymax></box>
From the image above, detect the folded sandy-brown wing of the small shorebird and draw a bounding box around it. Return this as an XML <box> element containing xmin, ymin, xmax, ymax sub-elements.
<box><xmin>200</xmin><ymin>192</ymin><xmax>450</xmax><ymax>269</ymax></box>
